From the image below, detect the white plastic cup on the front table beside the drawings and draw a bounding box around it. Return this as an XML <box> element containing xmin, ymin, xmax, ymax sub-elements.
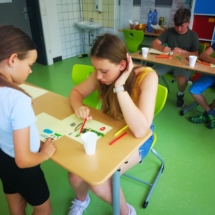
<box><xmin>81</xmin><ymin>132</ymin><xmax>98</xmax><ymax>155</ymax></box>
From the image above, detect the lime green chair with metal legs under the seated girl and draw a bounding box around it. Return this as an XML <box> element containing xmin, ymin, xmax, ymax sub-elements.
<box><xmin>123</xmin><ymin>85</ymin><xmax>168</xmax><ymax>208</ymax></box>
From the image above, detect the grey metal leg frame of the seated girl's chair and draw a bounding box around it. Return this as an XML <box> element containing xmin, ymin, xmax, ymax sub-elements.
<box><xmin>123</xmin><ymin>148</ymin><xmax>165</xmax><ymax>208</ymax></box>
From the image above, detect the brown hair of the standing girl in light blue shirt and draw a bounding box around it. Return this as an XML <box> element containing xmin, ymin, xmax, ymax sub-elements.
<box><xmin>0</xmin><ymin>25</ymin><xmax>36</xmax><ymax>94</ymax></box>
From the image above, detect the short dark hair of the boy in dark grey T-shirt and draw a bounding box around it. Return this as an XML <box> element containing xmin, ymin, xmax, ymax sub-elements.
<box><xmin>174</xmin><ymin>8</ymin><xmax>191</xmax><ymax>26</ymax></box>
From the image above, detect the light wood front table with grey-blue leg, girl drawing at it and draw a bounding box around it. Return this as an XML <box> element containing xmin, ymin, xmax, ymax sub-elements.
<box><xmin>33</xmin><ymin>86</ymin><xmax>152</xmax><ymax>215</ymax></box>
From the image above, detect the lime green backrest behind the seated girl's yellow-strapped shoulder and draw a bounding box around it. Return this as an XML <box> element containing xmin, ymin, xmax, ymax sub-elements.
<box><xmin>154</xmin><ymin>84</ymin><xmax>168</xmax><ymax>116</ymax></box>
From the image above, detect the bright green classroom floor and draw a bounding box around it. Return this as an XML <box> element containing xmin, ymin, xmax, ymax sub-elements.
<box><xmin>0</xmin><ymin>58</ymin><xmax>215</xmax><ymax>215</ymax></box>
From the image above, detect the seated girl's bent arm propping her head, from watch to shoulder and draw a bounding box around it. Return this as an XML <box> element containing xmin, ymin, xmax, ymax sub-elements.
<box><xmin>117</xmin><ymin>72</ymin><xmax>158</xmax><ymax>138</ymax></box>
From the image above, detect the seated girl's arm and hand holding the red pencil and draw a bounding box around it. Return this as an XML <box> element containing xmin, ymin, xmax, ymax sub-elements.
<box><xmin>69</xmin><ymin>72</ymin><xmax>97</xmax><ymax>119</ymax></box>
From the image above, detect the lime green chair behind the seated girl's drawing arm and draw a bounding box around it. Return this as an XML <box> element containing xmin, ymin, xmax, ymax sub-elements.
<box><xmin>71</xmin><ymin>64</ymin><xmax>100</xmax><ymax>109</ymax></box>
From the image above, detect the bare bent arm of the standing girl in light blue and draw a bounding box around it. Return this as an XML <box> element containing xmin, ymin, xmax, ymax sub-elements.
<box><xmin>13</xmin><ymin>127</ymin><xmax>56</xmax><ymax>168</ymax></box>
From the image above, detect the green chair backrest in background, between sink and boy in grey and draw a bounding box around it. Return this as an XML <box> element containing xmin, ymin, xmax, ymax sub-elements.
<box><xmin>123</xmin><ymin>29</ymin><xmax>144</xmax><ymax>53</ymax></box>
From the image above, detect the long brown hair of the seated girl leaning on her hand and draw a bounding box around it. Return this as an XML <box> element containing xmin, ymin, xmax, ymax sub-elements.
<box><xmin>90</xmin><ymin>34</ymin><xmax>140</xmax><ymax>119</ymax></box>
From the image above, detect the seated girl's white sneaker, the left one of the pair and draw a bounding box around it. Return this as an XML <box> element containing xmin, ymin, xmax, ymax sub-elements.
<box><xmin>68</xmin><ymin>195</ymin><xmax>90</xmax><ymax>215</ymax></box>
